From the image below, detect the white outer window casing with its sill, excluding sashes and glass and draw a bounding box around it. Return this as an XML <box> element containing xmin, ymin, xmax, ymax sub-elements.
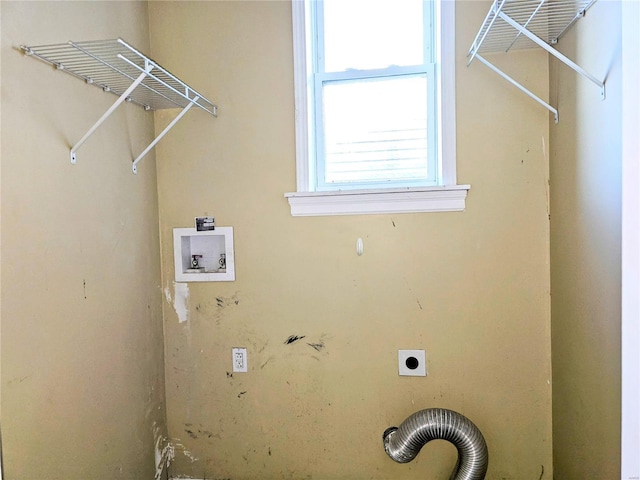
<box><xmin>285</xmin><ymin>0</ymin><xmax>470</xmax><ymax>216</ymax></box>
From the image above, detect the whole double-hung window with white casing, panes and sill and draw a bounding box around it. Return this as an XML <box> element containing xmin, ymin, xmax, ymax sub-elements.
<box><xmin>285</xmin><ymin>0</ymin><xmax>469</xmax><ymax>215</ymax></box>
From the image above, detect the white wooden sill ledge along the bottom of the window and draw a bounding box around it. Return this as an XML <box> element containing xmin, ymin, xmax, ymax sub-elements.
<box><xmin>284</xmin><ymin>185</ymin><xmax>471</xmax><ymax>217</ymax></box>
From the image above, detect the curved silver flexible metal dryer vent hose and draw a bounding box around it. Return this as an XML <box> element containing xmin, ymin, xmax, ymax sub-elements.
<box><xmin>382</xmin><ymin>408</ymin><xmax>489</xmax><ymax>480</ymax></box>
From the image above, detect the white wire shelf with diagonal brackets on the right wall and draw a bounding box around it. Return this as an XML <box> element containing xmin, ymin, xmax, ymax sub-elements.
<box><xmin>468</xmin><ymin>0</ymin><xmax>605</xmax><ymax>123</ymax></box>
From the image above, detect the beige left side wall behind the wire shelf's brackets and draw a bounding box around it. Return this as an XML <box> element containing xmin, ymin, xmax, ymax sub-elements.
<box><xmin>1</xmin><ymin>1</ymin><xmax>166</xmax><ymax>480</ymax></box>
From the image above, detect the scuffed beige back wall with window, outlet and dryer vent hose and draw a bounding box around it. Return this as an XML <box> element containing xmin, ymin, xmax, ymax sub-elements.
<box><xmin>149</xmin><ymin>1</ymin><xmax>552</xmax><ymax>479</ymax></box>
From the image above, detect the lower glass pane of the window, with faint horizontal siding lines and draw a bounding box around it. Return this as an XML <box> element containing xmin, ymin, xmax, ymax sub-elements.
<box><xmin>320</xmin><ymin>74</ymin><xmax>432</xmax><ymax>184</ymax></box>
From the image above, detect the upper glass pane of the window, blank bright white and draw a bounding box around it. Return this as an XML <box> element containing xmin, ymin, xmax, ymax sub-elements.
<box><xmin>321</xmin><ymin>0</ymin><xmax>424</xmax><ymax>72</ymax></box>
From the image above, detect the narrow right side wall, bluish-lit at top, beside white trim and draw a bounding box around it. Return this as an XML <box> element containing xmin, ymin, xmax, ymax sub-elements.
<box><xmin>550</xmin><ymin>2</ymin><xmax>622</xmax><ymax>478</ymax></box>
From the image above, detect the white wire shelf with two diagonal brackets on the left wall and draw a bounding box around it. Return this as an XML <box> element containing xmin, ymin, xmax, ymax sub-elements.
<box><xmin>21</xmin><ymin>38</ymin><xmax>218</xmax><ymax>173</ymax></box>
